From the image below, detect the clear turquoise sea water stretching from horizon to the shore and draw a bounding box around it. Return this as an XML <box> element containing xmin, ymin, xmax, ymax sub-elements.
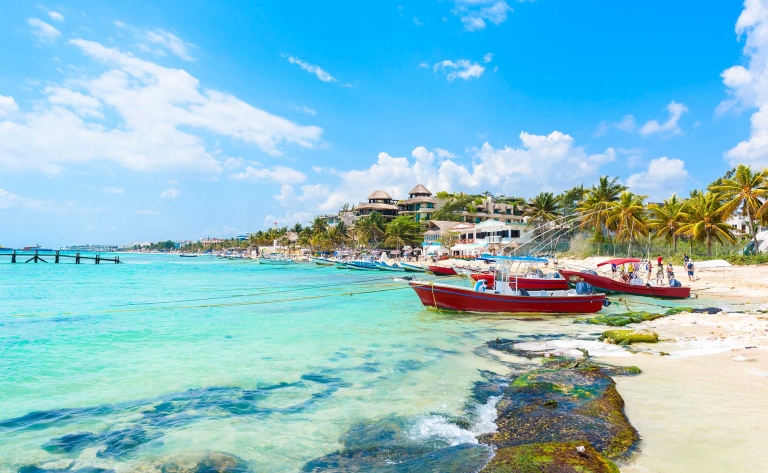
<box><xmin>0</xmin><ymin>255</ymin><xmax>728</xmax><ymax>472</ymax></box>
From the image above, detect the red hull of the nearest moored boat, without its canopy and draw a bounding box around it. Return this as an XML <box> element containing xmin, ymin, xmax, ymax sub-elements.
<box><xmin>409</xmin><ymin>282</ymin><xmax>605</xmax><ymax>314</ymax></box>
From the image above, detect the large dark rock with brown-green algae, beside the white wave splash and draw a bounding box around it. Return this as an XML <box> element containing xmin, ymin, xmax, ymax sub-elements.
<box><xmin>479</xmin><ymin>367</ymin><xmax>639</xmax><ymax>458</ymax></box>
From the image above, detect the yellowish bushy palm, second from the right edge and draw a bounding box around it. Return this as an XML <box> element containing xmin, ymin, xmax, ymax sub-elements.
<box><xmin>675</xmin><ymin>191</ymin><xmax>736</xmax><ymax>256</ymax></box>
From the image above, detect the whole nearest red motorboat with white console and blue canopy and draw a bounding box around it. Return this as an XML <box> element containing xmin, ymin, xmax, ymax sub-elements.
<box><xmin>408</xmin><ymin>257</ymin><xmax>608</xmax><ymax>314</ymax></box>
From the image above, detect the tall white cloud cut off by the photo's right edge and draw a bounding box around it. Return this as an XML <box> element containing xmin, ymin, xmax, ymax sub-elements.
<box><xmin>718</xmin><ymin>0</ymin><xmax>768</xmax><ymax>167</ymax></box>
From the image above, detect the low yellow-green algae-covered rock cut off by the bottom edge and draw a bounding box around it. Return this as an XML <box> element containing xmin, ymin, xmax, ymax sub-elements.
<box><xmin>482</xmin><ymin>441</ymin><xmax>619</xmax><ymax>473</ymax></box>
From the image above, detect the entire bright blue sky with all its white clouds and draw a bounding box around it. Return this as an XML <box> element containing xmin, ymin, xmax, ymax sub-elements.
<box><xmin>0</xmin><ymin>0</ymin><xmax>768</xmax><ymax>243</ymax></box>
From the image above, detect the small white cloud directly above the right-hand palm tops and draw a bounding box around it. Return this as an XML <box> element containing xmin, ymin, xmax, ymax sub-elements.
<box><xmin>627</xmin><ymin>156</ymin><xmax>690</xmax><ymax>198</ymax></box>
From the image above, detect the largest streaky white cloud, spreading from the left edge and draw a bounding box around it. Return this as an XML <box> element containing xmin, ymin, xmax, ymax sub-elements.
<box><xmin>0</xmin><ymin>39</ymin><xmax>322</xmax><ymax>174</ymax></box>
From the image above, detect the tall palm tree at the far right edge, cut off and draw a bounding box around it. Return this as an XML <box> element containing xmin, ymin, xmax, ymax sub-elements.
<box><xmin>711</xmin><ymin>164</ymin><xmax>768</xmax><ymax>253</ymax></box>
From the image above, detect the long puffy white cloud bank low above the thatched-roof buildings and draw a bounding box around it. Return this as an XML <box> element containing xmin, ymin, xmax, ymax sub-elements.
<box><xmin>268</xmin><ymin>131</ymin><xmax>616</xmax><ymax>223</ymax></box>
